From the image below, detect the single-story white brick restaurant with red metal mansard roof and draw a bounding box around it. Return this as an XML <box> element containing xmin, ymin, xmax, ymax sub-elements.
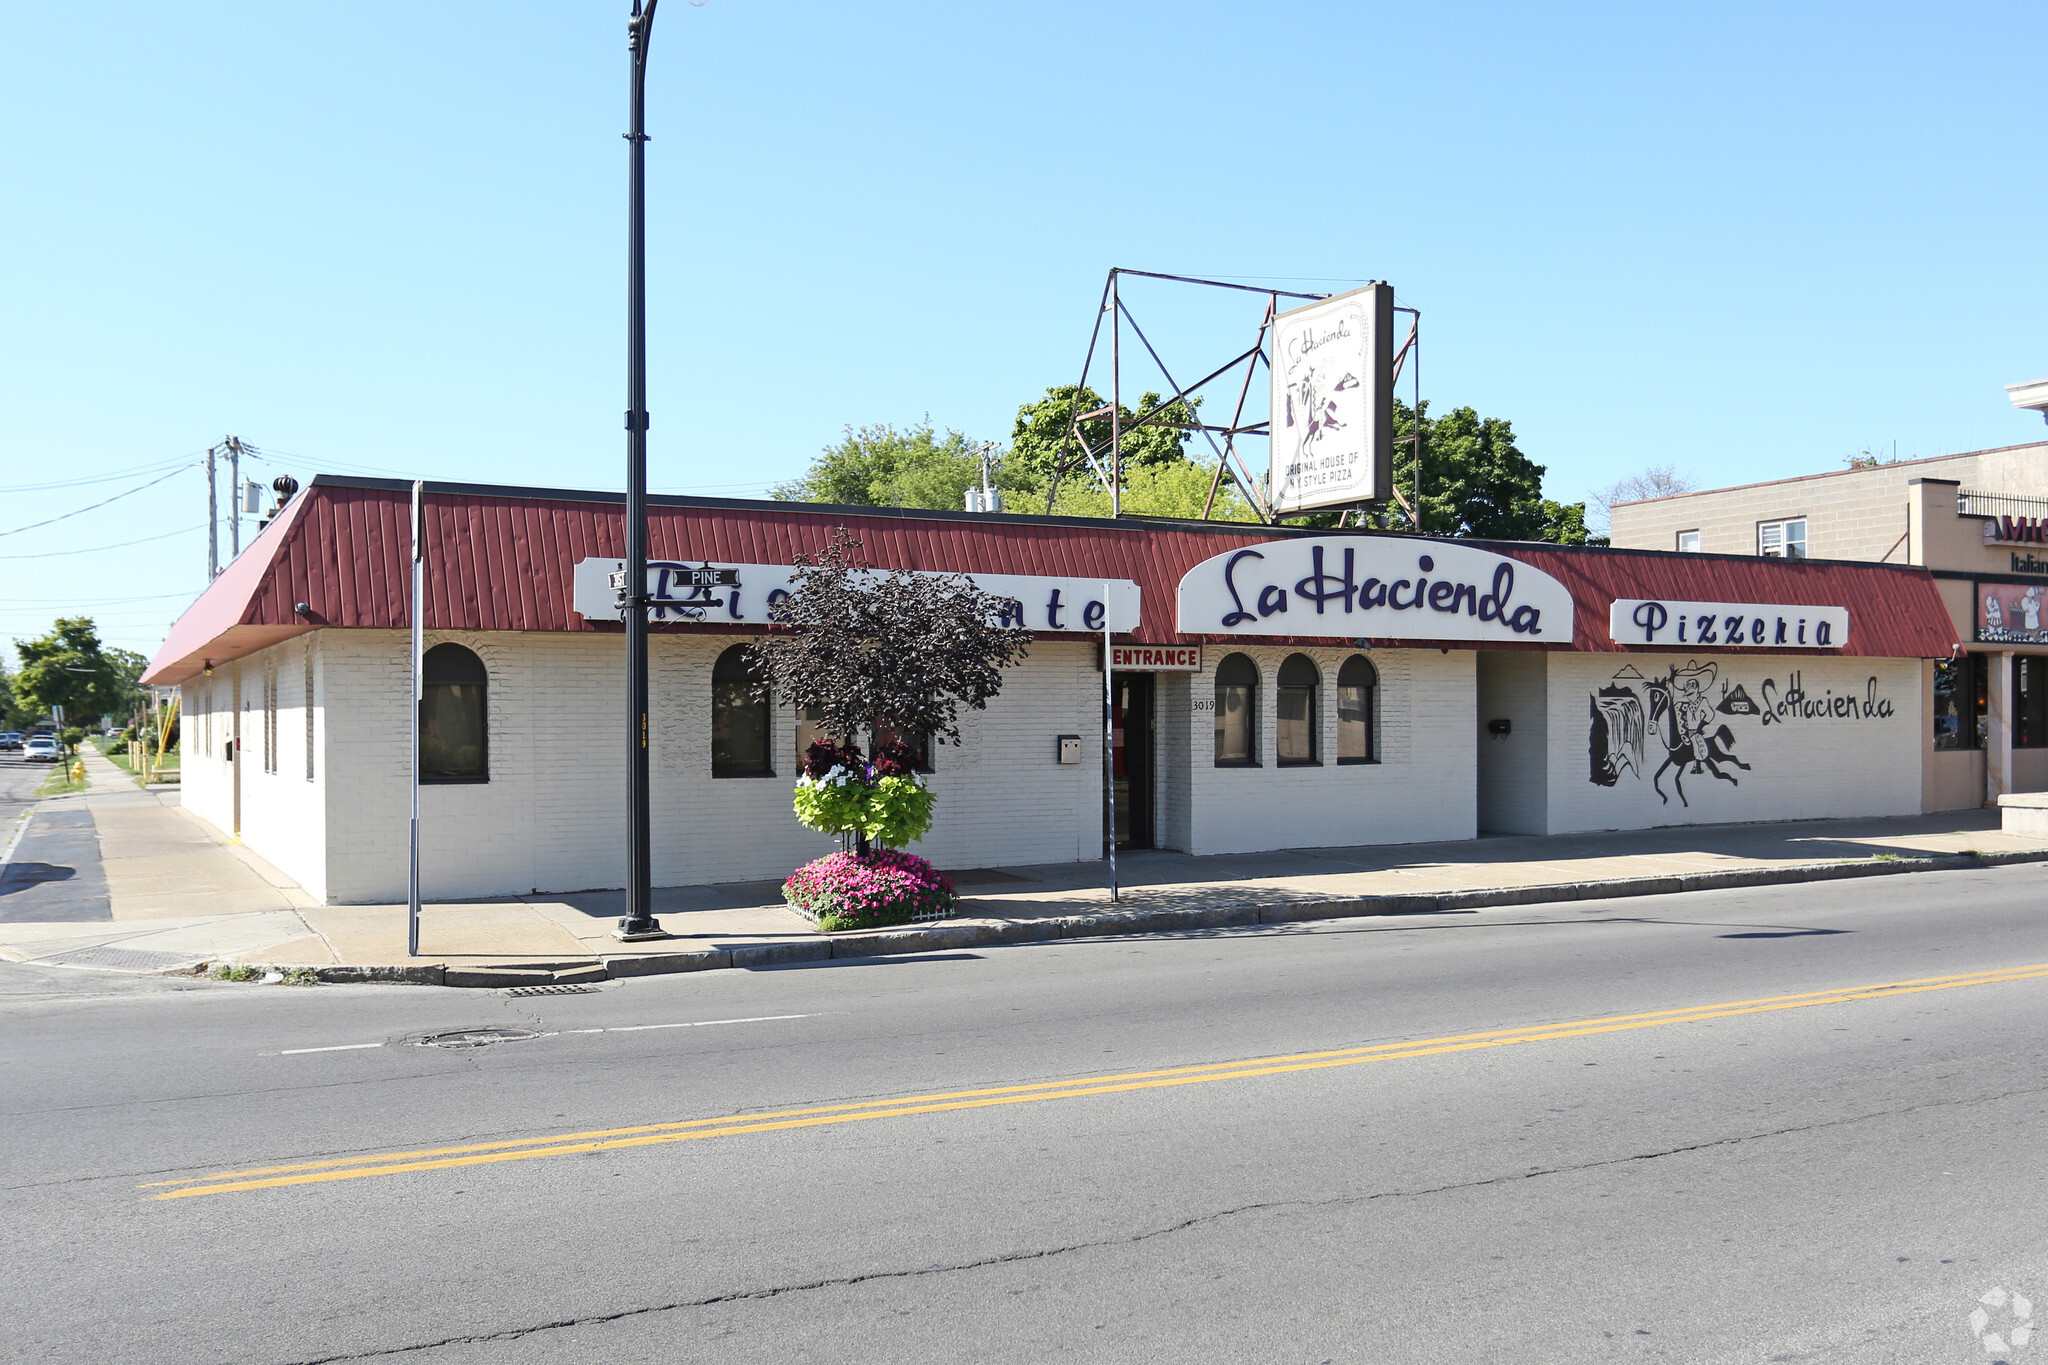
<box><xmin>145</xmin><ymin>477</ymin><xmax>1960</xmax><ymax>905</ymax></box>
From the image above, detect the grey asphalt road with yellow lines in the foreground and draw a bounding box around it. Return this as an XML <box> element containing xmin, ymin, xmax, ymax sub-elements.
<box><xmin>0</xmin><ymin>866</ymin><xmax>2048</xmax><ymax>1365</ymax></box>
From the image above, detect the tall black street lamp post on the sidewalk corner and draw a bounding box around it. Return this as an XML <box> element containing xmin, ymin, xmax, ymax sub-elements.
<box><xmin>612</xmin><ymin>0</ymin><xmax>668</xmax><ymax>939</ymax></box>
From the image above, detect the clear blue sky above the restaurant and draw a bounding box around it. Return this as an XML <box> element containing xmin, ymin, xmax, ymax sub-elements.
<box><xmin>0</xmin><ymin>0</ymin><xmax>2048</xmax><ymax>653</ymax></box>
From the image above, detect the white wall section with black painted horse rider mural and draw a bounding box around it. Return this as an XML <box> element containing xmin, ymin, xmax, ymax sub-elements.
<box><xmin>1548</xmin><ymin>655</ymin><xmax>1927</xmax><ymax>833</ymax></box>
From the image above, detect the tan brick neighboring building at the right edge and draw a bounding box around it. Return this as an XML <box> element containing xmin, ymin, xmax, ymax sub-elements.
<box><xmin>1612</xmin><ymin>439</ymin><xmax>2048</xmax><ymax>810</ymax></box>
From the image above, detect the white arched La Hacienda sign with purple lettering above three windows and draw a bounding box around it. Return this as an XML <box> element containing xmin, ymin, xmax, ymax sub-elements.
<box><xmin>1178</xmin><ymin>536</ymin><xmax>1571</xmax><ymax>645</ymax></box>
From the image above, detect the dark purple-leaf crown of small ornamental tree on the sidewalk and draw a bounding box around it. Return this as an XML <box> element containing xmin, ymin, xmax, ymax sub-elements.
<box><xmin>748</xmin><ymin>526</ymin><xmax>1030</xmax><ymax>745</ymax></box>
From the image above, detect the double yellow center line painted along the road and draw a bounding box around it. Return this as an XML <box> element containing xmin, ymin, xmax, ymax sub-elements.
<box><xmin>139</xmin><ymin>962</ymin><xmax>2048</xmax><ymax>1199</ymax></box>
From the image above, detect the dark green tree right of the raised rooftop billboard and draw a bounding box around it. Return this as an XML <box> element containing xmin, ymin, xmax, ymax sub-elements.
<box><xmin>1382</xmin><ymin>399</ymin><xmax>1585</xmax><ymax>544</ymax></box>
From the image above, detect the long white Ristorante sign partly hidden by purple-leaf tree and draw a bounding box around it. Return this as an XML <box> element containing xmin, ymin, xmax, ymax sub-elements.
<box><xmin>573</xmin><ymin>559</ymin><xmax>1139</xmax><ymax>634</ymax></box>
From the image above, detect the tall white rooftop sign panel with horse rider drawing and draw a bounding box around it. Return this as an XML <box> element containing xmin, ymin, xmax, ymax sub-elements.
<box><xmin>1270</xmin><ymin>282</ymin><xmax>1395</xmax><ymax>512</ymax></box>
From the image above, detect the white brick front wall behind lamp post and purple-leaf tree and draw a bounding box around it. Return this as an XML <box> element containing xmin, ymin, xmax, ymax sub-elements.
<box><xmin>294</xmin><ymin>630</ymin><xmax>1102</xmax><ymax>902</ymax></box>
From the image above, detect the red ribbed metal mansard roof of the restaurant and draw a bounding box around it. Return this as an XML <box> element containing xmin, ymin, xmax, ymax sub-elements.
<box><xmin>145</xmin><ymin>475</ymin><xmax>1958</xmax><ymax>684</ymax></box>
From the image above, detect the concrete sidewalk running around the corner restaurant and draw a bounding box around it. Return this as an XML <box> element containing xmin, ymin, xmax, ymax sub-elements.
<box><xmin>0</xmin><ymin>740</ymin><xmax>2048</xmax><ymax>986</ymax></box>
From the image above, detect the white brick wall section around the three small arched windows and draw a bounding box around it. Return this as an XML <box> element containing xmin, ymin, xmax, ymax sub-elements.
<box><xmin>1188</xmin><ymin>647</ymin><xmax>1477</xmax><ymax>853</ymax></box>
